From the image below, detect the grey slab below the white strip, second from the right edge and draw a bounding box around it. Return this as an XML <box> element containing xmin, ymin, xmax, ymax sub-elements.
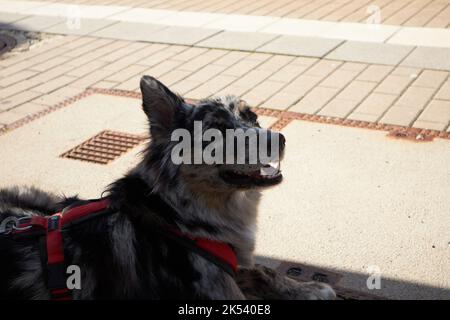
<box><xmin>326</xmin><ymin>41</ymin><xmax>413</xmax><ymax>65</ymax></box>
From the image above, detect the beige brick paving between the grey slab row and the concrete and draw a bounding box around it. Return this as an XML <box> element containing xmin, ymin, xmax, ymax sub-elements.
<box><xmin>0</xmin><ymin>35</ymin><xmax>450</xmax><ymax>130</ymax></box>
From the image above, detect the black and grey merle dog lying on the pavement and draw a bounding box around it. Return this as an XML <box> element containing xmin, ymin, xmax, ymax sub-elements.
<box><xmin>0</xmin><ymin>76</ymin><xmax>335</xmax><ymax>299</ymax></box>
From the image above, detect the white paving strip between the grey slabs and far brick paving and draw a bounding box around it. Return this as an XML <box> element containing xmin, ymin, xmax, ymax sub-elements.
<box><xmin>0</xmin><ymin>0</ymin><xmax>450</xmax><ymax>48</ymax></box>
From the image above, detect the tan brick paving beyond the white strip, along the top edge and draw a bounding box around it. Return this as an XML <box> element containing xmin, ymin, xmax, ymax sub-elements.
<box><xmin>37</xmin><ymin>0</ymin><xmax>450</xmax><ymax>28</ymax></box>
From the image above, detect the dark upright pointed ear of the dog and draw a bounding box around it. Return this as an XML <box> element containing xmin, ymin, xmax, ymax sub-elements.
<box><xmin>140</xmin><ymin>76</ymin><xmax>184</xmax><ymax>137</ymax></box>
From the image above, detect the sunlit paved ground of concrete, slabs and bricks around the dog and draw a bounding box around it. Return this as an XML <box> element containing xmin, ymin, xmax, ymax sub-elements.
<box><xmin>0</xmin><ymin>0</ymin><xmax>450</xmax><ymax>299</ymax></box>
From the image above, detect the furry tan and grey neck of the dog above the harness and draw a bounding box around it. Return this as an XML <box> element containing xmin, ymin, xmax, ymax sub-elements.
<box><xmin>133</xmin><ymin>166</ymin><xmax>260</xmax><ymax>266</ymax></box>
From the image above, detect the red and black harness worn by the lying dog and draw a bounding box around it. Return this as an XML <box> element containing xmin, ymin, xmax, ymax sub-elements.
<box><xmin>11</xmin><ymin>199</ymin><xmax>237</xmax><ymax>300</ymax></box>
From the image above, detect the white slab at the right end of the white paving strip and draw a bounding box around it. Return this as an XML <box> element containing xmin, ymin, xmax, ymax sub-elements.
<box><xmin>387</xmin><ymin>27</ymin><xmax>450</xmax><ymax>48</ymax></box>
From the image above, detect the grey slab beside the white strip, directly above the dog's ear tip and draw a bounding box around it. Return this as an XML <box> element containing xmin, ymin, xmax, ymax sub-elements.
<box><xmin>92</xmin><ymin>22</ymin><xmax>166</xmax><ymax>41</ymax></box>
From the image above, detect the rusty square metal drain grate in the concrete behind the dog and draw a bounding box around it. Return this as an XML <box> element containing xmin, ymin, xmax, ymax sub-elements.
<box><xmin>61</xmin><ymin>130</ymin><xmax>146</xmax><ymax>164</ymax></box>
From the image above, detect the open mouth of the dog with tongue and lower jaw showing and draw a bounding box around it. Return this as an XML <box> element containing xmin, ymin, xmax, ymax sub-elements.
<box><xmin>220</xmin><ymin>161</ymin><xmax>283</xmax><ymax>186</ymax></box>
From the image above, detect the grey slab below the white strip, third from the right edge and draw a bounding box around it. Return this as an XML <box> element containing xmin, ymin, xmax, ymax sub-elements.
<box><xmin>256</xmin><ymin>36</ymin><xmax>342</xmax><ymax>58</ymax></box>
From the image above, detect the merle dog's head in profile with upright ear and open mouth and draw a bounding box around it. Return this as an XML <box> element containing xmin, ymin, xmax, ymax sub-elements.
<box><xmin>140</xmin><ymin>76</ymin><xmax>285</xmax><ymax>191</ymax></box>
